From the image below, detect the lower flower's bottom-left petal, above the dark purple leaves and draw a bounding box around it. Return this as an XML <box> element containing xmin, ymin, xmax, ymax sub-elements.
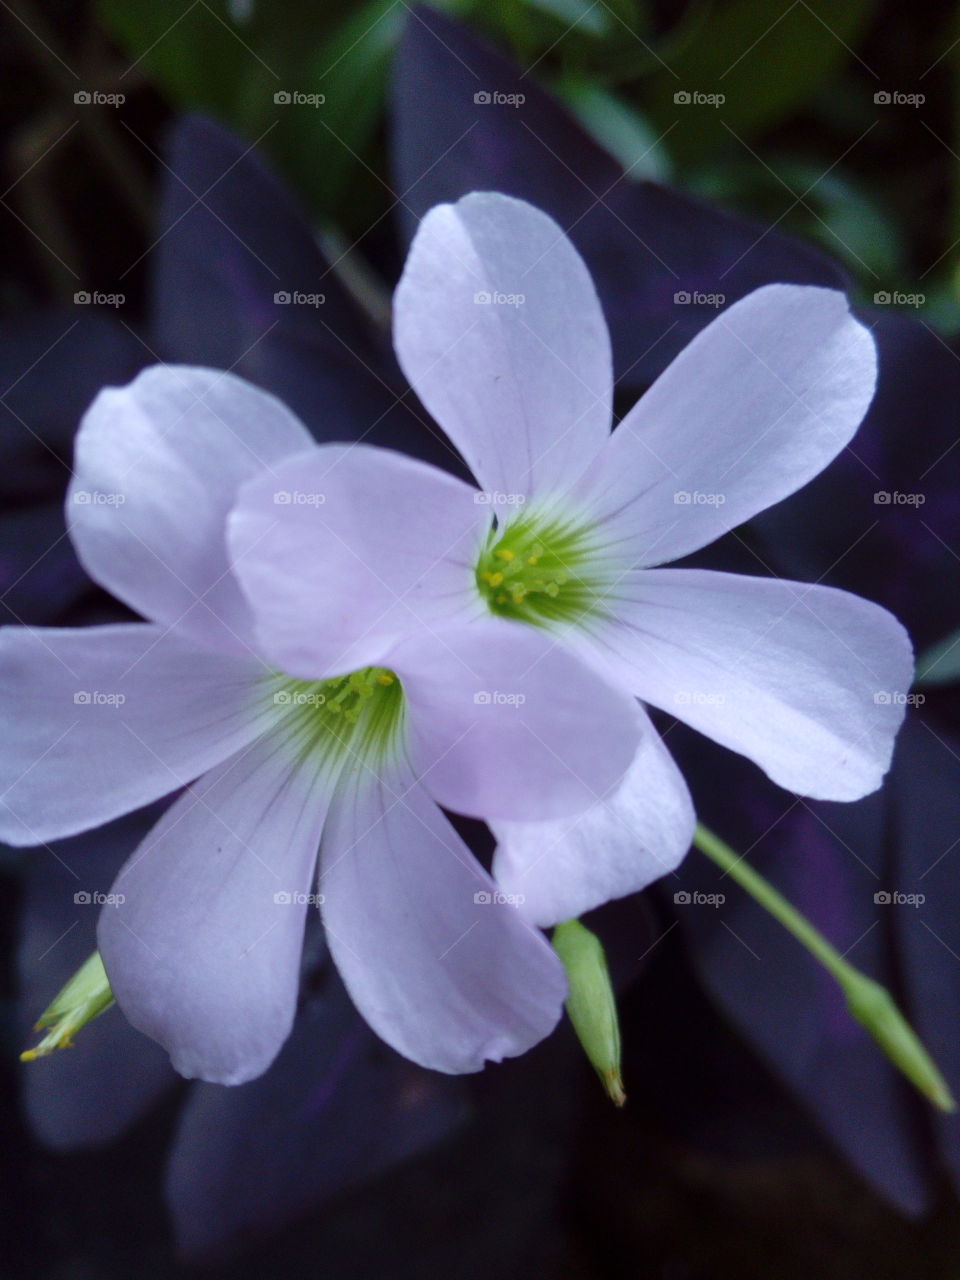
<box><xmin>99</xmin><ymin>735</ymin><xmax>330</xmax><ymax>1084</ymax></box>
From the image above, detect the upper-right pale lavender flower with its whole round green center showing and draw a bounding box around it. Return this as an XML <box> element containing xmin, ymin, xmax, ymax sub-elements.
<box><xmin>230</xmin><ymin>193</ymin><xmax>911</xmax><ymax>925</ymax></box>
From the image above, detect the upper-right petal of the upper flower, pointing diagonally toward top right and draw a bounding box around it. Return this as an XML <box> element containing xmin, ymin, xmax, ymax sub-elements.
<box><xmin>580</xmin><ymin>284</ymin><xmax>877</xmax><ymax>566</ymax></box>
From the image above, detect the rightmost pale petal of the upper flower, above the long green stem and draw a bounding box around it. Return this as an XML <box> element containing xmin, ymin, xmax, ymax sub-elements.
<box><xmin>595</xmin><ymin>570</ymin><xmax>913</xmax><ymax>800</ymax></box>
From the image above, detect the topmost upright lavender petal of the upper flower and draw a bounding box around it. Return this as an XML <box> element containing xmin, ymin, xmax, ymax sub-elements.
<box><xmin>394</xmin><ymin>192</ymin><xmax>613</xmax><ymax>495</ymax></box>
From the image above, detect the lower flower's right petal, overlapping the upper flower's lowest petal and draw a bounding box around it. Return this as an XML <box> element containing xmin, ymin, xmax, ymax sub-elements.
<box><xmin>385</xmin><ymin>618</ymin><xmax>641</xmax><ymax>822</ymax></box>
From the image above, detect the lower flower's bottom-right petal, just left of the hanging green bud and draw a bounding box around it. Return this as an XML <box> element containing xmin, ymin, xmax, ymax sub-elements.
<box><xmin>320</xmin><ymin>763</ymin><xmax>566</xmax><ymax>1074</ymax></box>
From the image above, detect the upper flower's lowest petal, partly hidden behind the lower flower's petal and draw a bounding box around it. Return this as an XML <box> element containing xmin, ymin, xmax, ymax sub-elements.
<box><xmin>492</xmin><ymin>722</ymin><xmax>696</xmax><ymax>928</ymax></box>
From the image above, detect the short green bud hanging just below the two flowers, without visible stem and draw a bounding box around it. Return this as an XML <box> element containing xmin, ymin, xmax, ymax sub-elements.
<box><xmin>553</xmin><ymin>920</ymin><xmax>627</xmax><ymax>1107</ymax></box>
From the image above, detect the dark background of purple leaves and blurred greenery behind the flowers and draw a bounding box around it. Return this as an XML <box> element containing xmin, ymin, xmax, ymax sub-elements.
<box><xmin>0</xmin><ymin>0</ymin><xmax>960</xmax><ymax>1280</ymax></box>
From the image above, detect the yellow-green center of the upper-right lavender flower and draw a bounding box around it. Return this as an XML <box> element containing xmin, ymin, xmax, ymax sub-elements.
<box><xmin>476</xmin><ymin>512</ymin><xmax>600</xmax><ymax>626</ymax></box>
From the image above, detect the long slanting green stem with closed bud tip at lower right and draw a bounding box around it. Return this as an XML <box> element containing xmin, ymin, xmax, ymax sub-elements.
<box><xmin>694</xmin><ymin>823</ymin><xmax>956</xmax><ymax>1111</ymax></box>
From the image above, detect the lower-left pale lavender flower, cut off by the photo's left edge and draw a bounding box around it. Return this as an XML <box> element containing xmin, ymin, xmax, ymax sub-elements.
<box><xmin>0</xmin><ymin>367</ymin><xmax>639</xmax><ymax>1083</ymax></box>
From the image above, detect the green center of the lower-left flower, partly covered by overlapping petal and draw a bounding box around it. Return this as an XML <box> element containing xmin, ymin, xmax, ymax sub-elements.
<box><xmin>269</xmin><ymin>667</ymin><xmax>403</xmax><ymax>765</ymax></box>
